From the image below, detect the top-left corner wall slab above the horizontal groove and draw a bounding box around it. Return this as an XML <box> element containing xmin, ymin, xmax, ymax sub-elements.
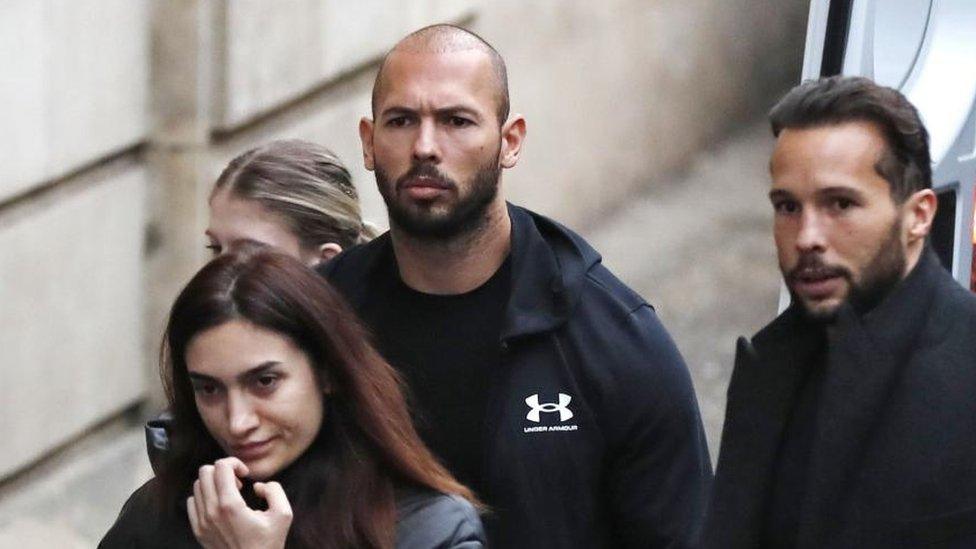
<box><xmin>0</xmin><ymin>0</ymin><xmax>149</xmax><ymax>200</ymax></box>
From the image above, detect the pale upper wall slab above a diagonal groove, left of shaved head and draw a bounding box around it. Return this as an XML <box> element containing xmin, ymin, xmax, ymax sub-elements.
<box><xmin>215</xmin><ymin>0</ymin><xmax>473</xmax><ymax>129</ymax></box>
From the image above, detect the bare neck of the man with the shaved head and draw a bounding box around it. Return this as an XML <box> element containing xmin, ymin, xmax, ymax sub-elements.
<box><xmin>390</xmin><ymin>198</ymin><xmax>512</xmax><ymax>295</ymax></box>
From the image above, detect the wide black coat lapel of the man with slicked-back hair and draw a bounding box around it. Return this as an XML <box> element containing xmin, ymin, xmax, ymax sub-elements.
<box><xmin>800</xmin><ymin>250</ymin><xmax>941</xmax><ymax>545</ymax></box>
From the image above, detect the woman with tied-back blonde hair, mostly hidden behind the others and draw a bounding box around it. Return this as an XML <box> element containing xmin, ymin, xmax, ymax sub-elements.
<box><xmin>146</xmin><ymin>139</ymin><xmax>376</xmax><ymax>470</ymax></box>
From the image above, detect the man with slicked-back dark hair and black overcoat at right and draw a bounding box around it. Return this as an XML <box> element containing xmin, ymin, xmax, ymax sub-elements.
<box><xmin>705</xmin><ymin>77</ymin><xmax>976</xmax><ymax>548</ymax></box>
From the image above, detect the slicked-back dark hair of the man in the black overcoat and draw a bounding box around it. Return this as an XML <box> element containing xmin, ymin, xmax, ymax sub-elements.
<box><xmin>769</xmin><ymin>76</ymin><xmax>932</xmax><ymax>199</ymax></box>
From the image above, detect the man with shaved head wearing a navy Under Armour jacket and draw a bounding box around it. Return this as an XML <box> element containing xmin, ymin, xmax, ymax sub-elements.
<box><xmin>322</xmin><ymin>25</ymin><xmax>711</xmax><ymax>549</ymax></box>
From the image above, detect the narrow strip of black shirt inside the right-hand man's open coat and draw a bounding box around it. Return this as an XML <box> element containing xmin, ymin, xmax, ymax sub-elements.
<box><xmin>763</xmin><ymin>334</ymin><xmax>826</xmax><ymax>549</ymax></box>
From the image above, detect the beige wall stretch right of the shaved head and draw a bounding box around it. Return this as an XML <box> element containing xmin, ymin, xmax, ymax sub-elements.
<box><xmin>475</xmin><ymin>0</ymin><xmax>807</xmax><ymax>224</ymax></box>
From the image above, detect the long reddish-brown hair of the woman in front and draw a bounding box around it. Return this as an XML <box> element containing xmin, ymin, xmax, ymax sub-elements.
<box><xmin>159</xmin><ymin>246</ymin><xmax>478</xmax><ymax>548</ymax></box>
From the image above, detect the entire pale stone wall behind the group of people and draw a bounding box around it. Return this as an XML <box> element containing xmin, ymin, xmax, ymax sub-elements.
<box><xmin>0</xmin><ymin>0</ymin><xmax>806</xmax><ymax>479</ymax></box>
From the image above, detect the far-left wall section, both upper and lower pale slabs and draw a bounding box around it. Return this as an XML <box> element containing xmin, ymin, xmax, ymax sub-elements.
<box><xmin>0</xmin><ymin>0</ymin><xmax>150</xmax><ymax>478</ymax></box>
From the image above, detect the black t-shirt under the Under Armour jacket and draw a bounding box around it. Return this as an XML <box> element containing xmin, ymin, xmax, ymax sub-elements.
<box><xmin>370</xmin><ymin>258</ymin><xmax>511</xmax><ymax>494</ymax></box>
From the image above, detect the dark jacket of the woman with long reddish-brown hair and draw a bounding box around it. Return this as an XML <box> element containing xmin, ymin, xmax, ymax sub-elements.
<box><xmin>98</xmin><ymin>479</ymin><xmax>485</xmax><ymax>549</ymax></box>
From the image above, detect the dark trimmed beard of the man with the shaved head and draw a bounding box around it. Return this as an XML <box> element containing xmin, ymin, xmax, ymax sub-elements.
<box><xmin>375</xmin><ymin>154</ymin><xmax>502</xmax><ymax>240</ymax></box>
